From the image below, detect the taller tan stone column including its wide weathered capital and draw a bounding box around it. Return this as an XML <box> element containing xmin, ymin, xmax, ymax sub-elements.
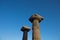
<box><xmin>29</xmin><ymin>14</ymin><xmax>43</xmax><ymax>40</ymax></box>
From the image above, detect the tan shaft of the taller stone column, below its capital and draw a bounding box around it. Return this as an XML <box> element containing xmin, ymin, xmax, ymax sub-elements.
<box><xmin>32</xmin><ymin>19</ymin><xmax>40</xmax><ymax>40</ymax></box>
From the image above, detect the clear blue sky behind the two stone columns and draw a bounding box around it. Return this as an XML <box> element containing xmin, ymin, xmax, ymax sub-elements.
<box><xmin>0</xmin><ymin>0</ymin><xmax>60</xmax><ymax>40</ymax></box>
